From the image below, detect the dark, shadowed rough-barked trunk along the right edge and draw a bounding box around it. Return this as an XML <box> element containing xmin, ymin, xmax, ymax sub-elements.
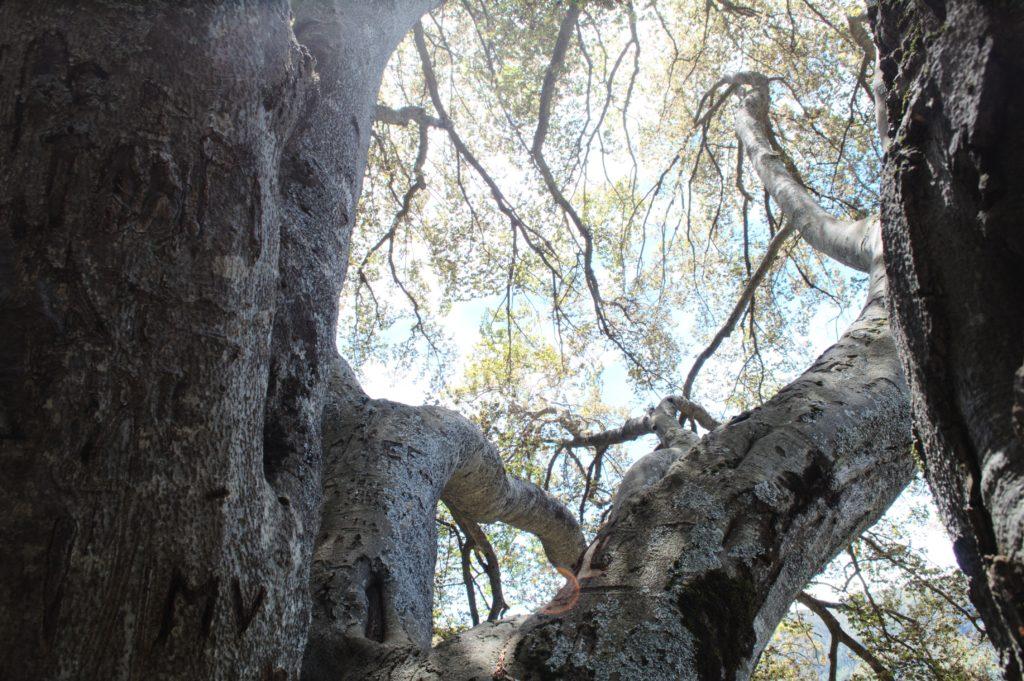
<box><xmin>876</xmin><ymin>0</ymin><xmax>1024</xmax><ymax>678</ymax></box>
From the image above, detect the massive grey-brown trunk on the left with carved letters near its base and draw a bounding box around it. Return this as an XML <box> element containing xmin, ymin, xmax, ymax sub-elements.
<box><xmin>0</xmin><ymin>0</ymin><xmax>428</xmax><ymax>679</ymax></box>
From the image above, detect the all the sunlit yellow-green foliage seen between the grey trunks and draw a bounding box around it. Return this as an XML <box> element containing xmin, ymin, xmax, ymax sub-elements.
<box><xmin>339</xmin><ymin>0</ymin><xmax>991</xmax><ymax>679</ymax></box>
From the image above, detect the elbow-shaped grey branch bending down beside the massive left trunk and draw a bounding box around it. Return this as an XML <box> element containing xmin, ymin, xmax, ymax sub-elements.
<box><xmin>304</xmin><ymin>358</ymin><xmax>586</xmax><ymax>679</ymax></box>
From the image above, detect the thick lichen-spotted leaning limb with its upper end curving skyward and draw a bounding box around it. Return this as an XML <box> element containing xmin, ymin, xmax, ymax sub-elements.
<box><xmin>321</xmin><ymin>75</ymin><xmax>913</xmax><ymax>680</ymax></box>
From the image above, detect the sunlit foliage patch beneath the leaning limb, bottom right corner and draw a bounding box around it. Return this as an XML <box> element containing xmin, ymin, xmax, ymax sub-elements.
<box><xmin>756</xmin><ymin>479</ymin><xmax>999</xmax><ymax>681</ymax></box>
